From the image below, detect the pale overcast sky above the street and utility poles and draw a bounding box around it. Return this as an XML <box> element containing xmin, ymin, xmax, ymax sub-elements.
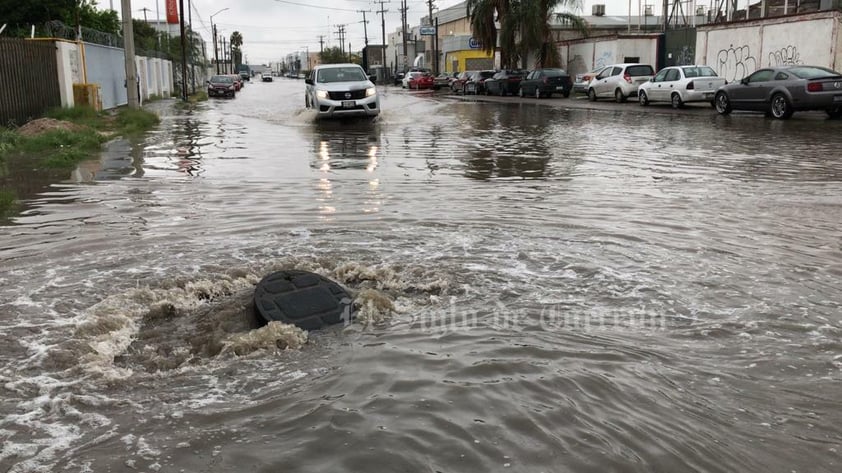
<box><xmin>108</xmin><ymin>0</ymin><xmax>640</xmax><ymax>64</ymax></box>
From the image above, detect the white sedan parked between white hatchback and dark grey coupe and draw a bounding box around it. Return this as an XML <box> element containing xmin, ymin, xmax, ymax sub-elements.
<box><xmin>637</xmin><ymin>66</ymin><xmax>726</xmax><ymax>108</ymax></box>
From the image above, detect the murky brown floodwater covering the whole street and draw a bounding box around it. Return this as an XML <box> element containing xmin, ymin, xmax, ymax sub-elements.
<box><xmin>0</xmin><ymin>79</ymin><xmax>842</xmax><ymax>473</ymax></box>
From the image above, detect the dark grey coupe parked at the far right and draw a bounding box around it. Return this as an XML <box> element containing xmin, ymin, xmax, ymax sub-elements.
<box><xmin>714</xmin><ymin>65</ymin><xmax>842</xmax><ymax>119</ymax></box>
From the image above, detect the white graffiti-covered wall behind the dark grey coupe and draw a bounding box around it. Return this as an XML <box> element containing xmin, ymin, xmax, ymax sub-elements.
<box><xmin>696</xmin><ymin>11</ymin><xmax>842</xmax><ymax>82</ymax></box>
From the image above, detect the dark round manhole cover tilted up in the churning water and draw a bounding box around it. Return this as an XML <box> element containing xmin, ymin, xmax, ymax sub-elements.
<box><xmin>254</xmin><ymin>270</ymin><xmax>353</xmax><ymax>330</ymax></box>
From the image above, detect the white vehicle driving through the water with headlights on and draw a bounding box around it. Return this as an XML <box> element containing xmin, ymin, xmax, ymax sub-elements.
<box><xmin>304</xmin><ymin>64</ymin><xmax>380</xmax><ymax>117</ymax></box>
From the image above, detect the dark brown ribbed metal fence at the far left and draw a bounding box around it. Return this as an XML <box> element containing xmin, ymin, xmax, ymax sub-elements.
<box><xmin>0</xmin><ymin>38</ymin><xmax>61</xmax><ymax>126</ymax></box>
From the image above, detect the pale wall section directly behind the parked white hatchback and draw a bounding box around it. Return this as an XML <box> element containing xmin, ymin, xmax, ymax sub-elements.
<box><xmin>558</xmin><ymin>35</ymin><xmax>660</xmax><ymax>75</ymax></box>
